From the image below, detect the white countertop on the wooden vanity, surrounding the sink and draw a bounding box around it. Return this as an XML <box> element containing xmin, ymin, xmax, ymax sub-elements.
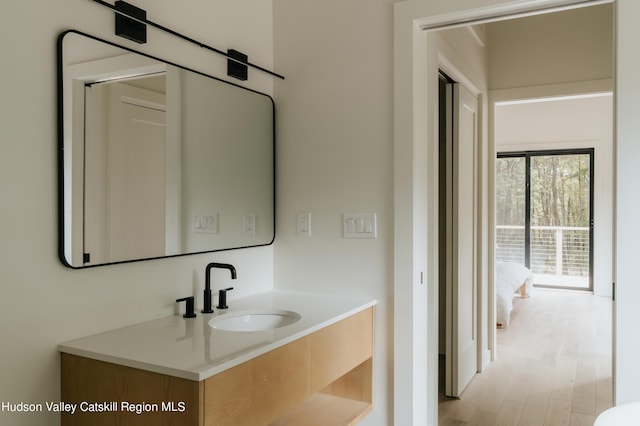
<box><xmin>58</xmin><ymin>291</ymin><xmax>376</xmax><ymax>381</ymax></box>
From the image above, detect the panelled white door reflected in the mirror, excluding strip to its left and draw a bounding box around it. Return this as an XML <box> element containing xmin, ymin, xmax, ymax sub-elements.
<box><xmin>108</xmin><ymin>85</ymin><xmax>166</xmax><ymax>262</ymax></box>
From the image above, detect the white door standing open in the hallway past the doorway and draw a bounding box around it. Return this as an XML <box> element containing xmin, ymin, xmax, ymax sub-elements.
<box><xmin>445</xmin><ymin>83</ymin><xmax>478</xmax><ymax>397</ymax></box>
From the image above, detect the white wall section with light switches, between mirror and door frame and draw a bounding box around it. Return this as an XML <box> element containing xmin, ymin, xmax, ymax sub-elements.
<box><xmin>274</xmin><ymin>0</ymin><xmax>393</xmax><ymax>425</ymax></box>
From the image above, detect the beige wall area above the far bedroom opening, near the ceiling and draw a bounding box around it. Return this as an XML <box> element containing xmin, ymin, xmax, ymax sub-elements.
<box><xmin>487</xmin><ymin>4</ymin><xmax>614</xmax><ymax>90</ymax></box>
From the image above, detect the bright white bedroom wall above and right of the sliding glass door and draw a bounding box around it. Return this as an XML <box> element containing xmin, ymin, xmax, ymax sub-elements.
<box><xmin>495</xmin><ymin>95</ymin><xmax>613</xmax><ymax>297</ymax></box>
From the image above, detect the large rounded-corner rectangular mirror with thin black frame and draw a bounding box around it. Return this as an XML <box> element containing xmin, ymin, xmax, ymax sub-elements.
<box><xmin>58</xmin><ymin>30</ymin><xmax>275</xmax><ymax>268</ymax></box>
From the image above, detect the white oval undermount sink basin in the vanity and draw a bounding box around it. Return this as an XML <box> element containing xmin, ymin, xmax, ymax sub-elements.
<box><xmin>209</xmin><ymin>309</ymin><xmax>300</xmax><ymax>332</ymax></box>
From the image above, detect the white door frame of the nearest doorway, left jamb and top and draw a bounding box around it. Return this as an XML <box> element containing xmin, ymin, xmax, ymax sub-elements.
<box><xmin>393</xmin><ymin>0</ymin><xmax>613</xmax><ymax>425</ymax></box>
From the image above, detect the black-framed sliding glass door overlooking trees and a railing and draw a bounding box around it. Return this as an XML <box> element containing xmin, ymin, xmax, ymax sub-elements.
<box><xmin>496</xmin><ymin>149</ymin><xmax>593</xmax><ymax>290</ymax></box>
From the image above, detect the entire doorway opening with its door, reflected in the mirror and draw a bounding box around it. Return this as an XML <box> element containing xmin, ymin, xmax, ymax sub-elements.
<box><xmin>83</xmin><ymin>82</ymin><xmax>167</xmax><ymax>264</ymax></box>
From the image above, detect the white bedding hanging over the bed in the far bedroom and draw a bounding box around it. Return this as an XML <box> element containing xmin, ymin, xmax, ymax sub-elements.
<box><xmin>496</xmin><ymin>262</ymin><xmax>533</xmax><ymax>327</ymax></box>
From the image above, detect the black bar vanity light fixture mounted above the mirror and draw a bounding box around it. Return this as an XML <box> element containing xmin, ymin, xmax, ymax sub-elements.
<box><xmin>86</xmin><ymin>0</ymin><xmax>284</xmax><ymax>81</ymax></box>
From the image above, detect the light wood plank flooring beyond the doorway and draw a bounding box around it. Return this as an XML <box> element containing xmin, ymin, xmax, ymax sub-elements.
<box><xmin>438</xmin><ymin>289</ymin><xmax>613</xmax><ymax>426</ymax></box>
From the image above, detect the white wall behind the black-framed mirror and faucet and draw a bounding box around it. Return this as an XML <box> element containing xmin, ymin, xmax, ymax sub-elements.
<box><xmin>0</xmin><ymin>0</ymin><xmax>273</xmax><ymax>426</ymax></box>
